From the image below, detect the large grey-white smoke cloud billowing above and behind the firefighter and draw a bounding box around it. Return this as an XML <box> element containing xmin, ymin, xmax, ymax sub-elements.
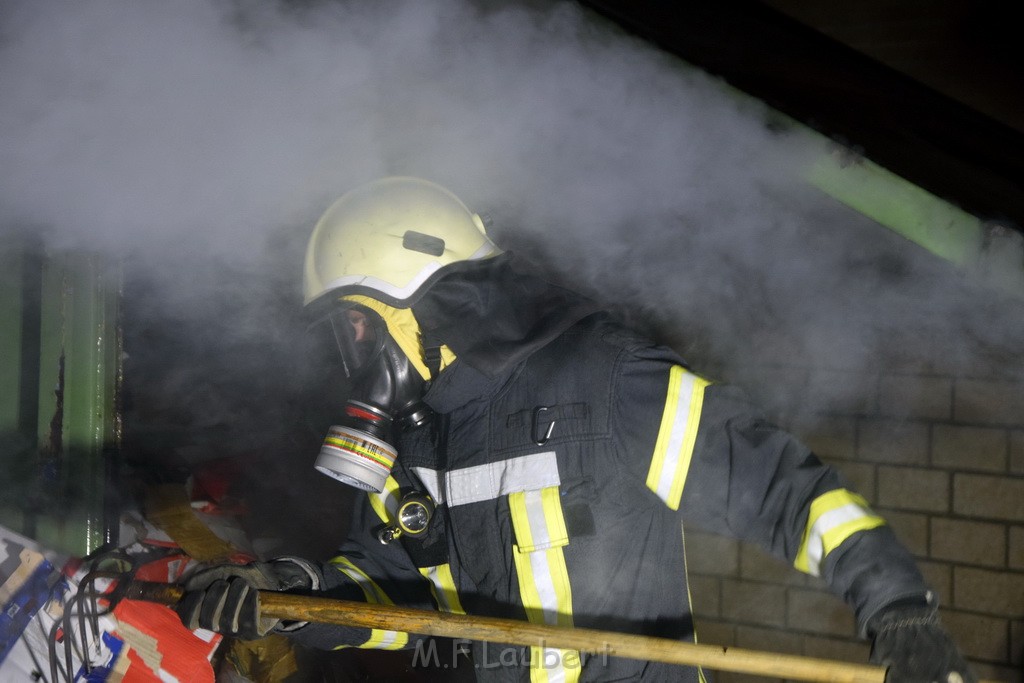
<box><xmin>0</xmin><ymin>0</ymin><xmax>1024</xmax><ymax>448</ymax></box>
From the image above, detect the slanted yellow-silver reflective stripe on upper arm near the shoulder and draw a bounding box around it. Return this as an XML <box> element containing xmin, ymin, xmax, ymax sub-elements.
<box><xmin>647</xmin><ymin>366</ymin><xmax>711</xmax><ymax>510</ymax></box>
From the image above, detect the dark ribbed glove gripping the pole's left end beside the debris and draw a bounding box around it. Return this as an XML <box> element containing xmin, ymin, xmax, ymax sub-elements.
<box><xmin>174</xmin><ymin>557</ymin><xmax>321</xmax><ymax>640</ymax></box>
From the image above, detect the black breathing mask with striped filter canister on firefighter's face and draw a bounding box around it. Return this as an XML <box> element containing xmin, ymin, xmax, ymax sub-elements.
<box><xmin>309</xmin><ymin>304</ymin><xmax>431</xmax><ymax>493</ymax></box>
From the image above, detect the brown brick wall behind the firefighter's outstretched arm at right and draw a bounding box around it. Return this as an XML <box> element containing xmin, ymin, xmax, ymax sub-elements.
<box><xmin>687</xmin><ymin>368</ymin><xmax>1024</xmax><ymax>683</ymax></box>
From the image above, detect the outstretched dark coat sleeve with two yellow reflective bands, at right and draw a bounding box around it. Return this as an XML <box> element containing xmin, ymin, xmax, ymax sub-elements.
<box><xmin>613</xmin><ymin>347</ymin><xmax>929</xmax><ymax>634</ymax></box>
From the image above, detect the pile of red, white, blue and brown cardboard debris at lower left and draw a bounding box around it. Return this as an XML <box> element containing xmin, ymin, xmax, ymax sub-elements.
<box><xmin>0</xmin><ymin>481</ymin><xmax>298</xmax><ymax>683</ymax></box>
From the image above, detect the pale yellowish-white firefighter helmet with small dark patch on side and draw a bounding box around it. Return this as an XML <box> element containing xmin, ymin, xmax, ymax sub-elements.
<box><xmin>303</xmin><ymin>176</ymin><xmax>501</xmax><ymax>308</ymax></box>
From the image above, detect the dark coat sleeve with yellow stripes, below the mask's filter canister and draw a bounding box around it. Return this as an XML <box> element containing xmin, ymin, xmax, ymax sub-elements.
<box><xmin>285</xmin><ymin>481</ymin><xmax>435</xmax><ymax>650</ymax></box>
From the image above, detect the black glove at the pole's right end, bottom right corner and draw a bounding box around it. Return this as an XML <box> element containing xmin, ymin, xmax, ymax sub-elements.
<box><xmin>868</xmin><ymin>602</ymin><xmax>978</xmax><ymax>683</ymax></box>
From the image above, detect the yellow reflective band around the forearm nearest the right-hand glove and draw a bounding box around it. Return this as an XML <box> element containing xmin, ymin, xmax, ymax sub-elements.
<box><xmin>793</xmin><ymin>488</ymin><xmax>886</xmax><ymax>577</ymax></box>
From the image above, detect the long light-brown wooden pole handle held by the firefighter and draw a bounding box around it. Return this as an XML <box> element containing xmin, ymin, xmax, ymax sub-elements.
<box><xmin>126</xmin><ymin>582</ymin><xmax>986</xmax><ymax>683</ymax></box>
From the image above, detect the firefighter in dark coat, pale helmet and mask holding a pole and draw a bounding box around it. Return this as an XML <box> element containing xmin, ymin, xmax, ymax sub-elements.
<box><xmin>178</xmin><ymin>177</ymin><xmax>975</xmax><ymax>683</ymax></box>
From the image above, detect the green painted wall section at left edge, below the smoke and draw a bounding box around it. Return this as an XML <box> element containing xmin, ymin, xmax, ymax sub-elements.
<box><xmin>0</xmin><ymin>241</ymin><xmax>121</xmax><ymax>555</ymax></box>
